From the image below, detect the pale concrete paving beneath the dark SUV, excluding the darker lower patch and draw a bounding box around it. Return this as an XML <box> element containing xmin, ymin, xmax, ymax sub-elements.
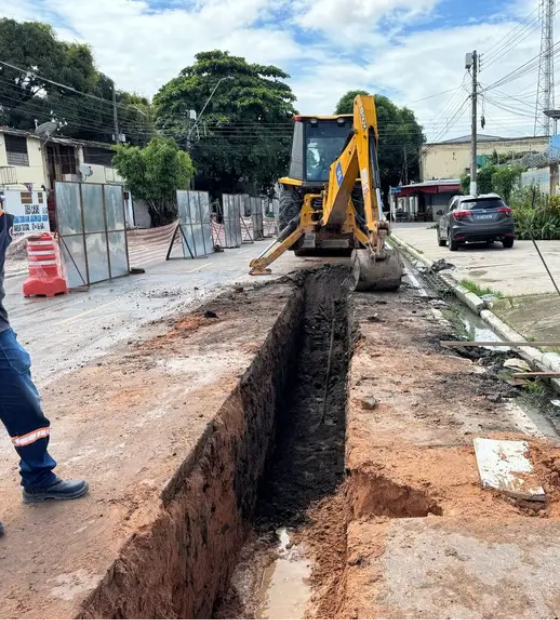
<box><xmin>393</xmin><ymin>224</ymin><xmax>560</xmax><ymax>296</ymax></box>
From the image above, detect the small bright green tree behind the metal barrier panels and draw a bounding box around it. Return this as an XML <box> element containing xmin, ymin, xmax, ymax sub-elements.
<box><xmin>113</xmin><ymin>136</ymin><xmax>194</xmax><ymax>226</ymax></box>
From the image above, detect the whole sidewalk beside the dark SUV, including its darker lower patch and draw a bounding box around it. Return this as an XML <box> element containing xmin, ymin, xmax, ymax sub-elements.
<box><xmin>393</xmin><ymin>224</ymin><xmax>560</xmax><ymax>341</ymax></box>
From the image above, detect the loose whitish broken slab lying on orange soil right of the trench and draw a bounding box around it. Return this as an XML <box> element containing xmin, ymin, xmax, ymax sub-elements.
<box><xmin>474</xmin><ymin>438</ymin><xmax>546</xmax><ymax>502</ymax></box>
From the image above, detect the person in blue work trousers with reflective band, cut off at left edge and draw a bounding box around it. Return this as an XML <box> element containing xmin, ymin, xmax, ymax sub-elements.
<box><xmin>0</xmin><ymin>195</ymin><xmax>88</xmax><ymax>535</ymax></box>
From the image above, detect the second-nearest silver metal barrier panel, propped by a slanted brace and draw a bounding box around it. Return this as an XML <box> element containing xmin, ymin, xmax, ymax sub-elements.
<box><xmin>177</xmin><ymin>190</ymin><xmax>214</xmax><ymax>258</ymax></box>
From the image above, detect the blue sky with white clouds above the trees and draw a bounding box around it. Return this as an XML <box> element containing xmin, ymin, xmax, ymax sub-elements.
<box><xmin>0</xmin><ymin>0</ymin><xmax>560</xmax><ymax>140</ymax></box>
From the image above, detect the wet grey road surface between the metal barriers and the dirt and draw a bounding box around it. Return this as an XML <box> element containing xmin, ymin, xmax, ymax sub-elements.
<box><xmin>5</xmin><ymin>241</ymin><xmax>306</xmax><ymax>386</ymax></box>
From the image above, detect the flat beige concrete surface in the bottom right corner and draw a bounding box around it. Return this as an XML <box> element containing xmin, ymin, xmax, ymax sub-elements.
<box><xmin>372</xmin><ymin>518</ymin><xmax>560</xmax><ymax>620</ymax></box>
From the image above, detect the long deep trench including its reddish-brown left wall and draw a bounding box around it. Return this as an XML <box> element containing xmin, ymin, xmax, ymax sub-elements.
<box><xmin>76</xmin><ymin>266</ymin><xmax>350</xmax><ymax>620</ymax></box>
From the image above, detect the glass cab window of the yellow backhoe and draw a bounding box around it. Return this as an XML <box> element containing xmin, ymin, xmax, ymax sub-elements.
<box><xmin>306</xmin><ymin>119</ymin><xmax>352</xmax><ymax>181</ymax></box>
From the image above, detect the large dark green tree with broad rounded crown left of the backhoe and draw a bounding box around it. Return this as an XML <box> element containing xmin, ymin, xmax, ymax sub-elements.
<box><xmin>154</xmin><ymin>51</ymin><xmax>295</xmax><ymax>194</ymax></box>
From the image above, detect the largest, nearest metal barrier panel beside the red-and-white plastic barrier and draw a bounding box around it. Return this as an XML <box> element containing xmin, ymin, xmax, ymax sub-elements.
<box><xmin>55</xmin><ymin>181</ymin><xmax>130</xmax><ymax>288</ymax></box>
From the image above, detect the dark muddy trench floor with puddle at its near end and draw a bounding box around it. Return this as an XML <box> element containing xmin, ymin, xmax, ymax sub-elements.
<box><xmin>214</xmin><ymin>267</ymin><xmax>352</xmax><ymax>620</ymax></box>
